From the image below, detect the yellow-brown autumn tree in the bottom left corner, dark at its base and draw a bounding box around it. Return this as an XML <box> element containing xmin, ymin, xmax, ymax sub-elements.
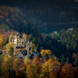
<box><xmin>1</xmin><ymin>56</ymin><xmax>15</xmax><ymax>78</ymax></box>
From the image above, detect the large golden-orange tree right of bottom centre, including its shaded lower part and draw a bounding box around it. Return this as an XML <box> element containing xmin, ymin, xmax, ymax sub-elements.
<box><xmin>40</xmin><ymin>58</ymin><xmax>60</xmax><ymax>78</ymax></box>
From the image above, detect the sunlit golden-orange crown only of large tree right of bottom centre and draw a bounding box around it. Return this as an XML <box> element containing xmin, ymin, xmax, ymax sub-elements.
<box><xmin>42</xmin><ymin>59</ymin><xmax>60</xmax><ymax>72</ymax></box>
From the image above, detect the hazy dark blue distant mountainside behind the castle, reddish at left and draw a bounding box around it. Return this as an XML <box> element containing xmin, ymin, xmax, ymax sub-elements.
<box><xmin>0</xmin><ymin>2</ymin><xmax>78</xmax><ymax>33</ymax></box>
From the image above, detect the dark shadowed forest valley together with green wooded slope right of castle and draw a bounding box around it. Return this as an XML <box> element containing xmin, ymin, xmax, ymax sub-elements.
<box><xmin>0</xmin><ymin>24</ymin><xmax>78</xmax><ymax>63</ymax></box>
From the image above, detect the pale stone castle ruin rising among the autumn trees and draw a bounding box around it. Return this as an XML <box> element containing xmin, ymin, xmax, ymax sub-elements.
<box><xmin>9</xmin><ymin>32</ymin><xmax>32</xmax><ymax>57</ymax></box>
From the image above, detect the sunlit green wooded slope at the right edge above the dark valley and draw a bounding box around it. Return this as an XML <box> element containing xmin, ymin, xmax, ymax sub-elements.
<box><xmin>52</xmin><ymin>29</ymin><xmax>78</xmax><ymax>51</ymax></box>
